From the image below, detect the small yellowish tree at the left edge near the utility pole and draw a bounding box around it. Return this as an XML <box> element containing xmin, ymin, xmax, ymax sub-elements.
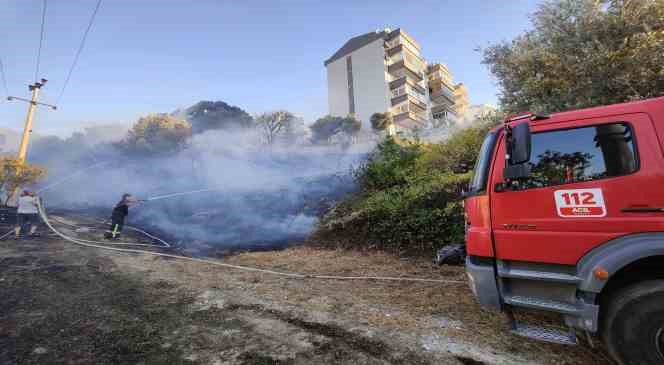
<box><xmin>0</xmin><ymin>156</ymin><xmax>46</xmax><ymax>205</ymax></box>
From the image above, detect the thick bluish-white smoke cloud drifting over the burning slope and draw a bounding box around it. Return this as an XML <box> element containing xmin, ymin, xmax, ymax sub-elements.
<box><xmin>33</xmin><ymin>126</ymin><xmax>373</xmax><ymax>254</ymax></box>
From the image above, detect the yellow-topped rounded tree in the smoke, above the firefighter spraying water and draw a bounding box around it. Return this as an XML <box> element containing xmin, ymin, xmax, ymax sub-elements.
<box><xmin>117</xmin><ymin>114</ymin><xmax>191</xmax><ymax>155</ymax></box>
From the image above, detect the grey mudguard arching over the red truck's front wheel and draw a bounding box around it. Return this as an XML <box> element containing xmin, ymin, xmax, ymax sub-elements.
<box><xmin>576</xmin><ymin>232</ymin><xmax>664</xmax><ymax>293</ymax></box>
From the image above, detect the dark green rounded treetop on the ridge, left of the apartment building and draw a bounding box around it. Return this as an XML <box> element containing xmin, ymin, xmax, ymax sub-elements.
<box><xmin>182</xmin><ymin>101</ymin><xmax>254</xmax><ymax>133</ymax></box>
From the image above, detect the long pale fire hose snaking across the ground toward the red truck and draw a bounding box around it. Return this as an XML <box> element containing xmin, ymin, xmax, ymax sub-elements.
<box><xmin>35</xmin><ymin>202</ymin><xmax>466</xmax><ymax>285</ymax></box>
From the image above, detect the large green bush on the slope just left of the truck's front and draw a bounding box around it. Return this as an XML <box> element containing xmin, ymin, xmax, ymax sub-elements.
<box><xmin>314</xmin><ymin>122</ymin><xmax>494</xmax><ymax>255</ymax></box>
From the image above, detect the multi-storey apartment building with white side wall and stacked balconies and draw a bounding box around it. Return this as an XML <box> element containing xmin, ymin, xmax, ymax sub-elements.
<box><xmin>324</xmin><ymin>28</ymin><xmax>468</xmax><ymax>131</ymax></box>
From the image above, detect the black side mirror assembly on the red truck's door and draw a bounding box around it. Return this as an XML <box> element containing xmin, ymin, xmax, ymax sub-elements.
<box><xmin>503</xmin><ymin>122</ymin><xmax>531</xmax><ymax>181</ymax></box>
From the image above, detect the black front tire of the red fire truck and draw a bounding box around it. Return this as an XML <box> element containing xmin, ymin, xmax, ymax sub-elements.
<box><xmin>602</xmin><ymin>280</ymin><xmax>664</xmax><ymax>365</ymax></box>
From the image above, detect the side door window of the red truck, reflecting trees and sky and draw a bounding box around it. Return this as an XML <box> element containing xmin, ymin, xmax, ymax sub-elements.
<box><xmin>510</xmin><ymin>123</ymin><xmax>638</xmax><ymax>188</ymax></box>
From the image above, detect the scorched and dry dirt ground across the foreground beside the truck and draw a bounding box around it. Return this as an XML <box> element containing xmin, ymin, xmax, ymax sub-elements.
<box><xmin>0</xmin><ymin>216</ymin><xmax>610</xmax><ymax>364</ymax></box>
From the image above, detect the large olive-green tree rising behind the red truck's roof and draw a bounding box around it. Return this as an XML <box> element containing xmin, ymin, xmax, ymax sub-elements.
<box><xmin>483</xmin><ymin>0</ymin><xmax>664</xmax><ymax>113</ymax></box>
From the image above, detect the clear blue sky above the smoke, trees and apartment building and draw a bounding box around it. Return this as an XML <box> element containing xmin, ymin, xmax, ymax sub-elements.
<box><xmin>0</xmin><ymin>0</ymin><xmax>537</xmax><ymax>135</ymax></box>
